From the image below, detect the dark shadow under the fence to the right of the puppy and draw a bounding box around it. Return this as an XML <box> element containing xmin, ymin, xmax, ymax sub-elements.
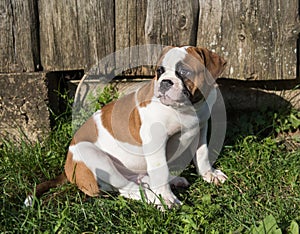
<box><xmin>220</xmin><ymin>84</ymin><xmax>300</xmax><ymax>145</ymax></box>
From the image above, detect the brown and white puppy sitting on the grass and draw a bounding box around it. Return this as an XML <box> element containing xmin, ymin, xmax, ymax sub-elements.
<box><xmin>25</xmin><ymin>46</ymin><xmax>227</xmax><ymax>207</ymax></box>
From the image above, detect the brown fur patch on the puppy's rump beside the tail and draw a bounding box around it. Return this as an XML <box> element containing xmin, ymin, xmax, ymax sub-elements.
<box><xmin>65</xmin><ymin>151</ymin><xmax>100</xmax><ymax>197</ymax></box>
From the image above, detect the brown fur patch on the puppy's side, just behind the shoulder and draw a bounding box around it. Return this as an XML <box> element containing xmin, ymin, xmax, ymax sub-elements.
<box><xmin>101</xmin><ymin>93</ymin><xmax>142</xmax><ymax>145</ymax></box>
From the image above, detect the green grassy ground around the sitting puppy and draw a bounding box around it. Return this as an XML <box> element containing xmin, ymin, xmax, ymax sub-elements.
<box><xmin>0</xmin><ymin>102</ymin><xmax>300</xmax><ymax>233</ymax></box>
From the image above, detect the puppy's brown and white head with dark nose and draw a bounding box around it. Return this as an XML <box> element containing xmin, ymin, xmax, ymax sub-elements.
<box><xmin>154</xmin><ymin>46</ymin><xmax>226</xmax><ymax>106</ymax></box>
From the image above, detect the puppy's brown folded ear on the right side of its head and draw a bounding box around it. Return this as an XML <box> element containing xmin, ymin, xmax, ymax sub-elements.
<box><xmin>194</xmin><ymin>47</ymin><xmax>227</xmax><ymax>79</ymax></box>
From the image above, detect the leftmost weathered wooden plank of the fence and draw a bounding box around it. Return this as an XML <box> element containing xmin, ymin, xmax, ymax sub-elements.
<box><xmin>0</xmin><ymin>0</ymin><xmax>39</xmax><ymax>72</ymax></box>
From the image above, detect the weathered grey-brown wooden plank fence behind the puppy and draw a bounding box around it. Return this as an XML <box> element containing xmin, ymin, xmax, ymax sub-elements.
<box><xmin>0</xmin><ymin>0</ymin><xmax>300</xmax><ymax>80</ymax></box>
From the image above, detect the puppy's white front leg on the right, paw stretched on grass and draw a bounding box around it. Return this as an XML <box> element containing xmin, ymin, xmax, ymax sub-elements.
<box><xmin>194</xmin><ymin>122</ymin><xmax>227</xmax><ymax>184</ymax></box>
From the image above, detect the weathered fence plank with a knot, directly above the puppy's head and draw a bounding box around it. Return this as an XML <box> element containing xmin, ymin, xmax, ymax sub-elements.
<box><xmin>145</xmin><ymin>0</ymin><xmax>199</xmax><ymax>46</ymax></box>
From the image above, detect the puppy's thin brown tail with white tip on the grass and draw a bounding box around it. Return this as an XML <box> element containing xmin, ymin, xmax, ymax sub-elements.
<box><xmin>24</xmin><ymin>172</ymin><xmax>68</xmax><ymax>206</ymax></box>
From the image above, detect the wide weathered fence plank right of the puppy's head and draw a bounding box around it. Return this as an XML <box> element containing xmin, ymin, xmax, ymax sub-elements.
<box><xmin>197</xmin><ymin>0</ymin><xmax>300</xmax><ymax>80</ymax></box>
